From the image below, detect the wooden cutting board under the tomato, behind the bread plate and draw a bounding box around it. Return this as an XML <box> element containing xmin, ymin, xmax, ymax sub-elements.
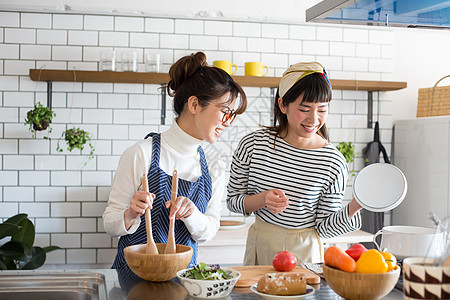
<box><xmin>230</xmin><ymin>266</ymin><xmax>320</xmax><ymax>287</ymax></box>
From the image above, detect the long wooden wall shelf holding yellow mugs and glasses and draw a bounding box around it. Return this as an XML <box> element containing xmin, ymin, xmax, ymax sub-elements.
<box><xmin>30</xmin><ymin>69</ymin><xmax>406</xmax><ymax>91</ymax></box>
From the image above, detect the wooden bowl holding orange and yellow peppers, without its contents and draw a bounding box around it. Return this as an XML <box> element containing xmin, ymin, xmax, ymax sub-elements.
<box><xmin>323</xmin><ymin>265</ymin><xmax>400</xmax><ymax>300</ymax></box>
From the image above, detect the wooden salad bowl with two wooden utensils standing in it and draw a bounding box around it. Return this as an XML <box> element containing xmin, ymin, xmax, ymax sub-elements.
<box><xmin>123</xmin><ymin>243</ymin><xmax>193</xmax><ymax>281</ymax></box>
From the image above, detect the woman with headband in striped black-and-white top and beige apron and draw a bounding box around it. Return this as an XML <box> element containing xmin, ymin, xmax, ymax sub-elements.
<box><xmin>227</xmin><ymin>62</ymin><xmax>361</xmax><ymax>265</ymax></box>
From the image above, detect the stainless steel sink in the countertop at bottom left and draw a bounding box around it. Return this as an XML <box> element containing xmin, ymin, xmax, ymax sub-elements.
<box><xmin>0</xmin><ymin>272</ymin><xmax>108</xmax><ymax>300</ymax></box>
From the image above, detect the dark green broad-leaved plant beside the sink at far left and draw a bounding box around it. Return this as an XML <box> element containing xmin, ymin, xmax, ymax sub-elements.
<box><xmin>0</xmin><ymin>214</ymin><xmax>61</xmax><ymax>270</ymax></box>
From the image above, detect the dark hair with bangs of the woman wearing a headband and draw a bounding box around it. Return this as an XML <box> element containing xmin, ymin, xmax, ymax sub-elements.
<box><xmin>267</xmin><ymin>73</ymin><xmax>331</xmax><ymax>141</ymax></box>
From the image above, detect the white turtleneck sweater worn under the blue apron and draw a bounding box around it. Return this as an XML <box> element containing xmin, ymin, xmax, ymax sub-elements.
<box><xmin>103</xmin><ymin>121</ymin><xmax>225</xmax><ymax>243</ymax></box>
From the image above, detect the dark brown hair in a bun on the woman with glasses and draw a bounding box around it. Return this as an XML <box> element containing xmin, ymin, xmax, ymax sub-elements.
<box><xmin>166</xmin><ymin>52</ymin><xmax>247</xmax><ymax>116</ymax></box>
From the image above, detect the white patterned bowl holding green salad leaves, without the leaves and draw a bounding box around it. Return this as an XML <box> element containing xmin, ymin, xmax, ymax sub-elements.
<box><xmin>177</xmin><ymin>268</ymin><xmax>241</xmax><ymax>298</ymax></box>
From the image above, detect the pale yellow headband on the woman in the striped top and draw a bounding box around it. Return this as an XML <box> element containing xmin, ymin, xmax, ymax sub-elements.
<box><xmin>278</xmin><ymin>62</ymin><xmax>329</xmax><ymax>97</ymax></box>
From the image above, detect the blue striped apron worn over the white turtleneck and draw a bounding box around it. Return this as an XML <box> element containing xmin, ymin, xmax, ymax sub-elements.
<box><xmin>112</xmin><ymin>133</ymin><xmax>212</xmax><ymax>269</ymax></box>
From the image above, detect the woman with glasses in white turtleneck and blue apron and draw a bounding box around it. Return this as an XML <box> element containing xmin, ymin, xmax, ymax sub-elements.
<box><xmin>103</xmin><ymin>52</ymin><xmax>247</xmax><ymax>269</ymax></box>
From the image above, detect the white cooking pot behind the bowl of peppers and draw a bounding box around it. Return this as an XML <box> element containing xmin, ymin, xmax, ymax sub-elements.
<box><xmin>373</xmin><ymin>226</ymin><xmax>444</xmax><ymax>259</ymax></box>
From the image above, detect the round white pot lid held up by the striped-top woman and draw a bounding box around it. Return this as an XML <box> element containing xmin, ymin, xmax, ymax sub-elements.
<box><xmin>353</xmin><ymin>163</ymin><xmax>407</xmax><ymax>212</ymax></box>
